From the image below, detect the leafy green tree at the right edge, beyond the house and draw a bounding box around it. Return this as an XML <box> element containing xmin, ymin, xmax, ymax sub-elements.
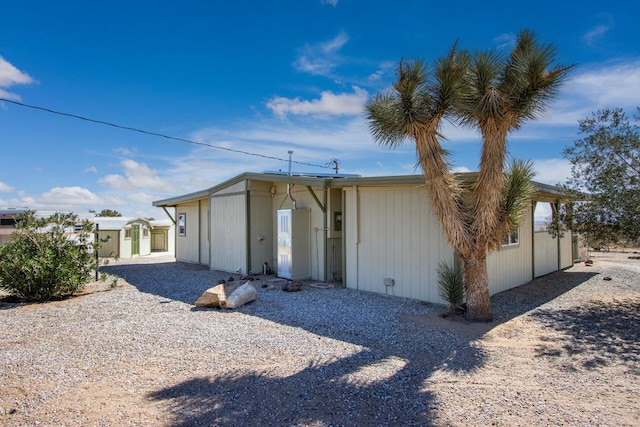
<box><xmin>562</xmin><ymin>108</ymin><xmax>640</xmax><ymax>245</ymax></box>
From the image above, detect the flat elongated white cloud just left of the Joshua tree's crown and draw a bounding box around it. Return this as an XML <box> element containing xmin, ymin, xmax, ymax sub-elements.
<box><xmin>267</xmin><ymin>86</ymin><xmax>369</xmax><ymax>118</ymax></box>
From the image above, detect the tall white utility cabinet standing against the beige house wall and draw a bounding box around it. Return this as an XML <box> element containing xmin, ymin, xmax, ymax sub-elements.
<box><xmin>278</xmin><ymin>209</ymin><xmax>311</xmax><ymax>280</ymax></box>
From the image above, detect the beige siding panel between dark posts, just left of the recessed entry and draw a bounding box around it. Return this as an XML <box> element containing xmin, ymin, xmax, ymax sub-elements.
<box><xmin>210</xmin><ymin>194</ymin><xmax>248</xmax><ymax>274</ymax></box>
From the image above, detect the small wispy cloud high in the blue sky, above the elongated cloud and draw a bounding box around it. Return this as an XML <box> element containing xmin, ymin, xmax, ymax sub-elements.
<box><xmin>293</xmin><ymin>32</ymin><xmax>349</xmax><ymax>76</ymax></box>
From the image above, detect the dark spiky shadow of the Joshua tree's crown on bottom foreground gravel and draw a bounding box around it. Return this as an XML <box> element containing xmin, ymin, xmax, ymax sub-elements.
<box><xmin>147</xmin><ymin>351</ymin><xmax>444</xmax><ymax>427</ymax></box>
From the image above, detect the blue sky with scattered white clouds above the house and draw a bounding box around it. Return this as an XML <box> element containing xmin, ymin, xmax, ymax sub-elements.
<box><xmin>0</xmin><ymin>0</ymin><xmax>640</xmax><ymax>218</ymax></box>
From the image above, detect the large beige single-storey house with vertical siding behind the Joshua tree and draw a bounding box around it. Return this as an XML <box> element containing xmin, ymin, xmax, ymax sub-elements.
<box><xmin>153</xmin><ymin>172</ymin><xmax>574</xmax><ymax>303</ymax></box>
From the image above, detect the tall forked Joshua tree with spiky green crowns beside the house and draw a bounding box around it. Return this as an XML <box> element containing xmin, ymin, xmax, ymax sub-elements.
<box><xmin>366</xmin><ymin>30</ymin><xmax>571</xmax><ymax>321</ymax></box>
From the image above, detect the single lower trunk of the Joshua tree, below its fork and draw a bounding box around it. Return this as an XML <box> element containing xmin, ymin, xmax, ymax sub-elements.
<box><xmin>463</xmin><ymin>252</ymin><xmax>492</xmax><ymax>322</ymax></box>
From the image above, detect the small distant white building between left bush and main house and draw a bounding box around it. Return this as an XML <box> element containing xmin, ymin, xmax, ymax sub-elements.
<box><xmin>93</xmin><ymin>217</ymin><xmax>175</xmax><ymax>258</ymax></box>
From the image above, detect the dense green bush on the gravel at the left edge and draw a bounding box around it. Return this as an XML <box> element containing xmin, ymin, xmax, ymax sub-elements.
<box><xmin>0</xmin><ymin>212</ymin><xmax>99</xmax><ymax>301</ymax></box>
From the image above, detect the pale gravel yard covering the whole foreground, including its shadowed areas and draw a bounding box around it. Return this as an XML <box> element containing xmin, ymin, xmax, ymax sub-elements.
<box><xmin>0</xmin><ymin>254</ymin><xmax>640</xmax><ymax>426</ymax></box>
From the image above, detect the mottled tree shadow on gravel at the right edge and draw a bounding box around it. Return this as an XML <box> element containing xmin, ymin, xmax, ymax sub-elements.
<box><xmin>531</xmin><ymin>299</ymin><xmax>640</xmax><ymax>375</ymax></box>
